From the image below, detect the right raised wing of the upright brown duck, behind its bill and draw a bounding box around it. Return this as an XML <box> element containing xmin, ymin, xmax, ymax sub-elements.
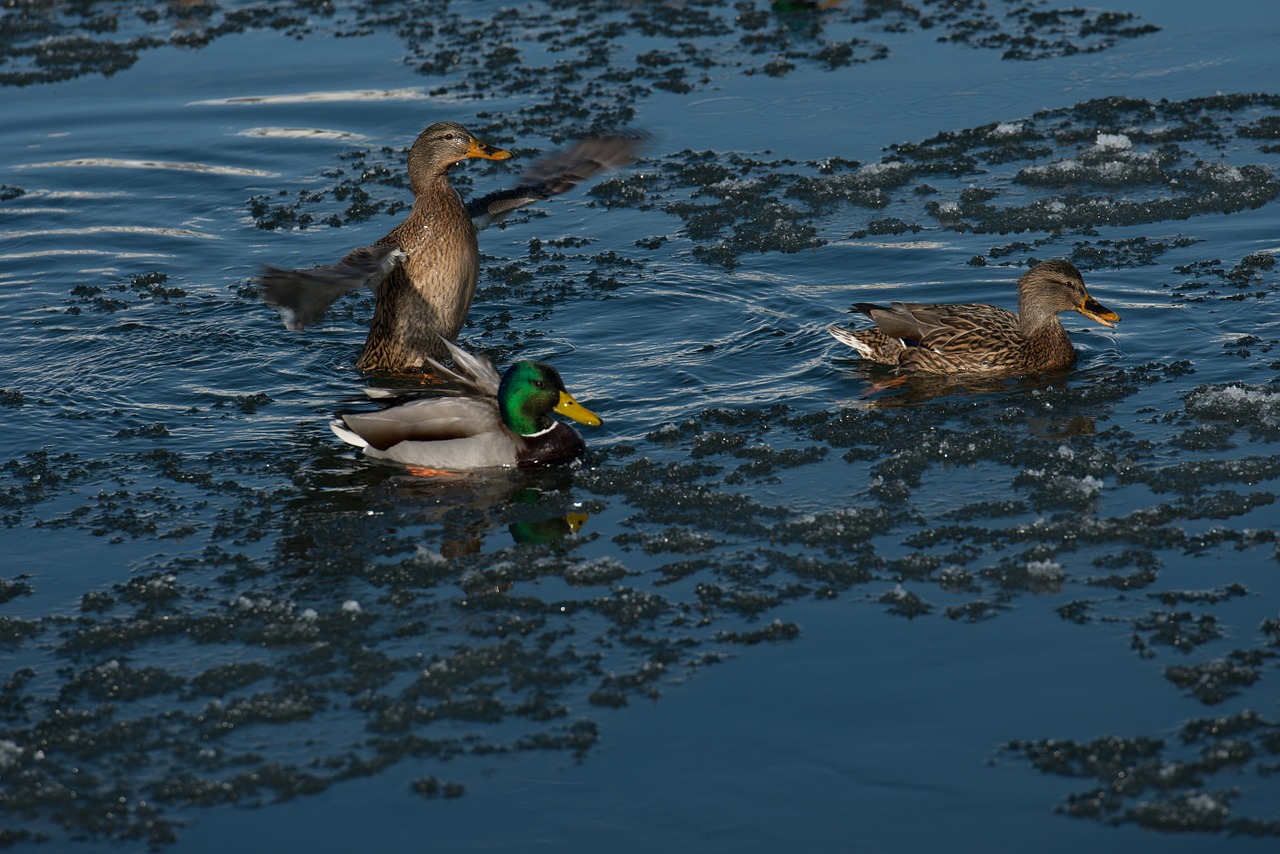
<box><xmin>467</xmin><ymin>132</ymin><xmax>649</xmax><ymax>230</ymax></box>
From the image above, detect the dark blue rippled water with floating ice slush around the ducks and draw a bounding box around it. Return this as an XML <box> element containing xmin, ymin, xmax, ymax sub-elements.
<box><xmin>0</xmin><ymin>1</ymin><xmax>1280</xmax><ymax>851</ymax></box>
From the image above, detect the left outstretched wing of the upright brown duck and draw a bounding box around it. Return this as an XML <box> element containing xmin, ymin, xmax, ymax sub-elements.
<box><xmin>259</xmin><ymin>243</ymin><xmax>406</xmax><ymax>332</ymax></box>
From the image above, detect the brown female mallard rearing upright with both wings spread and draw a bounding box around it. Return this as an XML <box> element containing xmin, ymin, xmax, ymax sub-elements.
<box><xmin>260</xmin><ymin>122</ymin><xmax>644</xmax><ymax>373</ymax></box>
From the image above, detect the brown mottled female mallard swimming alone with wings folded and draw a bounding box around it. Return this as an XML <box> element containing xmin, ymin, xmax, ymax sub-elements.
<box><xmin>827</xmin><ymin>260</ymin><xmax>1120</xmax><ymax>374</ymax></box>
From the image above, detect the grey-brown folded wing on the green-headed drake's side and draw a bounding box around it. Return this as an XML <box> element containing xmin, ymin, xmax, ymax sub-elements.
<box><xmin>329</xmin><ymin>397</ymin><xmax>502</xmax><ymax>451</ymax></box>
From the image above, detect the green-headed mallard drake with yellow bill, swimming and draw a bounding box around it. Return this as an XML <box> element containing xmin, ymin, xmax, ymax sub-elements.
<box><xmin>329</xmin><ymin>342</ymin><xmax>600</xmax><ymax>471</ymax></box>
